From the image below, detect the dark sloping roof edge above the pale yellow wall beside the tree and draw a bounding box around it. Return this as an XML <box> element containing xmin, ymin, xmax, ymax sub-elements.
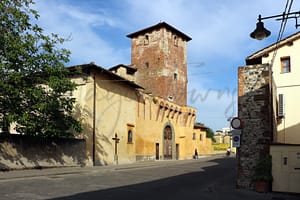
<box><xmin>67</xmin><ymin>63</ymin><xmax>144</xmax><ymax>89</ymax></box>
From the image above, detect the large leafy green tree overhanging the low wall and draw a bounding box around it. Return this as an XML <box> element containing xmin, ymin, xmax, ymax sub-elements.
<box><xmin>0</xmin><ymin>0</ymin><xmax>81</xmax><ymax>137</ymax></box>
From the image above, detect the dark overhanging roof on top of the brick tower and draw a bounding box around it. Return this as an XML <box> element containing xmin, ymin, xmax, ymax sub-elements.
<box><xmin>127</xmin><ymin>22</ymin><xmax>192</xmax><ymax>42</ymax></box>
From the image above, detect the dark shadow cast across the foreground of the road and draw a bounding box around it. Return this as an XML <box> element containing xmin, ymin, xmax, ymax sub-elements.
<box><xmin>48</xmin><ymin>158</ymin><xmax>296</xmax><ymax>200</ymax></box>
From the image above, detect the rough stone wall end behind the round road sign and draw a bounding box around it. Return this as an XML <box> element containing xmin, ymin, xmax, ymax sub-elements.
<box><xmin>237</xmin><ymin>64</ymin><xmax>273</xmax><ymax>189</ymax></box>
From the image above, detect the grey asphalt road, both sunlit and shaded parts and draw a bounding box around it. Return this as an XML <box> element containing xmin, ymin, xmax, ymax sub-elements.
<box><xmin>0</xmin><ymin>157</ymin><xmax>299</xmax><ymax>200</ymax></box>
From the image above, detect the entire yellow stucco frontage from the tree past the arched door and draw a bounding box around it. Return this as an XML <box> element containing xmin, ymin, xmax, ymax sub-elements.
<box><xmin>72</xmin><ymin>66</ymin><xmax>211</xmax><ymax>165</ymax></box>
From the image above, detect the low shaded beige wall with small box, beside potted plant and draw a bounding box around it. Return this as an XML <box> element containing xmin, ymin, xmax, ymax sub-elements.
<box><xmin>270</xmin><ymin>144</ymin><xmax>300</xmax><ymax>193</ymax></box>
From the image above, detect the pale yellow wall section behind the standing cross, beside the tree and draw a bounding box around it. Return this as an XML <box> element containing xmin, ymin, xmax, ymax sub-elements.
<box><xmin>73</xmin><ymin>70</ymin><xmax>137</xmax><ymax>165</ymax></box>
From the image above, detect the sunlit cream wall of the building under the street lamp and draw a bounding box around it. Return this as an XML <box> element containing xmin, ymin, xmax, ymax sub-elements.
<box><xmin>262</xmin><ymin>36</ymin><xmax>300</xmax><ymax>144</ymax></box>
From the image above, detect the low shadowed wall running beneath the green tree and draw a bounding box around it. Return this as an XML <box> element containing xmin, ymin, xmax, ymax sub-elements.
<box><xmin>0</xmin><ymin>134</ymin><xmax>86</xmax><ymax>171</ymax></box>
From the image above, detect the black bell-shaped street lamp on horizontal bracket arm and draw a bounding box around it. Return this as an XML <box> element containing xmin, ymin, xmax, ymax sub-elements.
<box><xmin>250</xmin><ymin>11</ymin><xmax>300</xmax><ymax>40</ymax></box>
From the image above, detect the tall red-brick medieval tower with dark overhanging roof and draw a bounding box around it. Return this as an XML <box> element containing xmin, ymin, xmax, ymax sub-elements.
<box><xmin>127</xmin><ymin>22</ymin><xmax>191</xmax><ymax>105</ymax></box>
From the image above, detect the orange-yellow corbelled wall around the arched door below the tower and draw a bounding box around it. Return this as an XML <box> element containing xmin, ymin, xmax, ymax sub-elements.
<box><xmin>136</xmin><ymin>95</ymin><xmax>207</xmax><ymax>160</ymax></box>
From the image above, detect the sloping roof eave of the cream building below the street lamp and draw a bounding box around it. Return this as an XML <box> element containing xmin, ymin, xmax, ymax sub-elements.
<box><xmin>246</xmin><ymin>31</ymin><xmax>300</xmax><ymax>60</ymax></box>
